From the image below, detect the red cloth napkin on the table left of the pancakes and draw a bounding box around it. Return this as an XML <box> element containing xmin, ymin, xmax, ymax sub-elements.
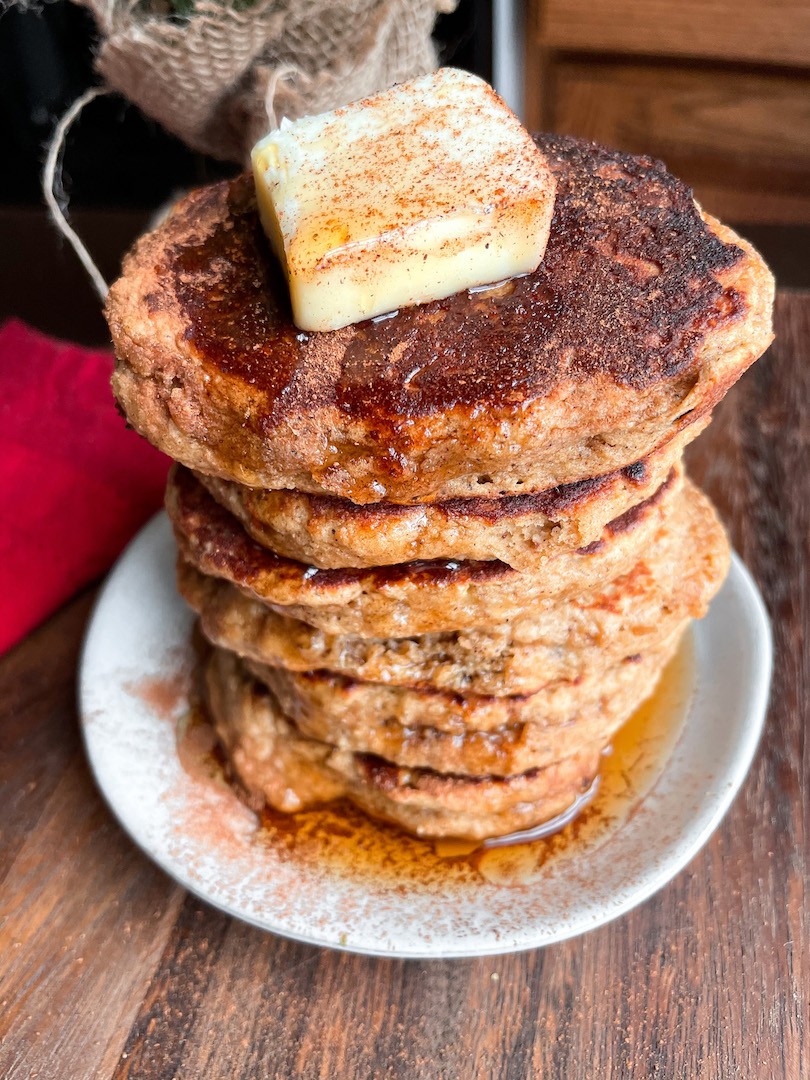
<box><xmin>0</xmin><ymin>320</ymin><xmax>170</xmax><ymax>652</ymax></box>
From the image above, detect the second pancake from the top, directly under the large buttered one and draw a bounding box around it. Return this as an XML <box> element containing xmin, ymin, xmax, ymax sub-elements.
<box><xmin>195</xmin><ymin>422</ymin><xmax>705</xmax><ymax>570</ymax></box>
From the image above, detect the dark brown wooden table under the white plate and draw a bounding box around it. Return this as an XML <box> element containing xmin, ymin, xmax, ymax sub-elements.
<box><xmin>0</xmin><ymin>293</ymin><xmax>810</xmax><ymax>1080</ymax></box>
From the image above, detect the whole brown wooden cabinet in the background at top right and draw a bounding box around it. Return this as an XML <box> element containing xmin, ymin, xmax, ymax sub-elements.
<box><xmin>526</xmin><ymin>0</ymin><xmax>810</xmax><ymax>224</ymax></box>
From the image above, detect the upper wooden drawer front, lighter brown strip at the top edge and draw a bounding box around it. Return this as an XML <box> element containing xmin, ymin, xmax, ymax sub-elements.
<box><xmin>535</xmin><ymin>0</ymin><xmax>810</xmax><ymax>67</ymax></box>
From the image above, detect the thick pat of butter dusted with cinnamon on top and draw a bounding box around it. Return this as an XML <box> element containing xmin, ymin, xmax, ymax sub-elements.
<box><xmin>252</xmin><ymin>68</ymin><xmax>555</xmax><ymax>330</ymax></box>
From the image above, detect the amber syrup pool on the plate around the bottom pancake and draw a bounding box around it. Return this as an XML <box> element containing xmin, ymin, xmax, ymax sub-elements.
<box><xmin>178</xmin><ymin>634</ymin><xmax>694</xmax><ymax>887</ymax></box>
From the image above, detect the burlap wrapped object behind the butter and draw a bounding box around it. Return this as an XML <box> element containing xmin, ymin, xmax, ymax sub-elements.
<box><xmin>78</xmin><ymin>0</ymin><xmax>456</xmax><ymax>163</ymax></box>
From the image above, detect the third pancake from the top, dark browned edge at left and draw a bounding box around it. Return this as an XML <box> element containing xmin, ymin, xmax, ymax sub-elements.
<box><xmin>166</xmin><ymin>468</ymin><xmax>684</xmax><ymax>637</ymax></box>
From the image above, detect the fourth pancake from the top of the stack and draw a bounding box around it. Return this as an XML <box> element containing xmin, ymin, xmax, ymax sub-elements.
<box><xmin>183</xmin><ymin>561</ymin><xmax>704</xmax><ymax>696</ymax></box>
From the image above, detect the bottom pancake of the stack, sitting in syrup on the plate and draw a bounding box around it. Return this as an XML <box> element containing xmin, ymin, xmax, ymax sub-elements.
<box><xmin>204</xmin><ymin>650</ymin><xmax>602</xmax><ymax>840</ymax></box>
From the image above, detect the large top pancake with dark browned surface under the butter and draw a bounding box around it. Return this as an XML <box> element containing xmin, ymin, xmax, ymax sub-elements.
<box><xmin>107</xmin><ymin>136</ymin><xmax>772</xmax><ymax>503</ymax></box>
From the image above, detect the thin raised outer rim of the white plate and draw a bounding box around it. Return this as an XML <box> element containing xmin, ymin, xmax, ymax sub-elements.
<box><xmin>77</xmin><ymin>511</ymin><xmax>773</xmax><ymax>960</ymax></box>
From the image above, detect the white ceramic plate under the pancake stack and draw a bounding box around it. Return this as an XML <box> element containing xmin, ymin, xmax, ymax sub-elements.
<box><xmin>80</xmin><ymin>514</ymin><xmax>772</xmax><ymax>958</ymax></box>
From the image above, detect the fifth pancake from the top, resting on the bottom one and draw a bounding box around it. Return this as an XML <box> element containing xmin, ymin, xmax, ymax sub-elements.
<box><xmin>245</xmin><ymin>636</ymin><xmax>678</xmax><ymax>777</ymax></box>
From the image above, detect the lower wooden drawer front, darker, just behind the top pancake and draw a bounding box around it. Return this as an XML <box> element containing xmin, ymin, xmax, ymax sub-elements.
<box><xmin>546</xmin><ymin>58</ymin><xmax>810</xmax><ymax>220</ymax></box>
